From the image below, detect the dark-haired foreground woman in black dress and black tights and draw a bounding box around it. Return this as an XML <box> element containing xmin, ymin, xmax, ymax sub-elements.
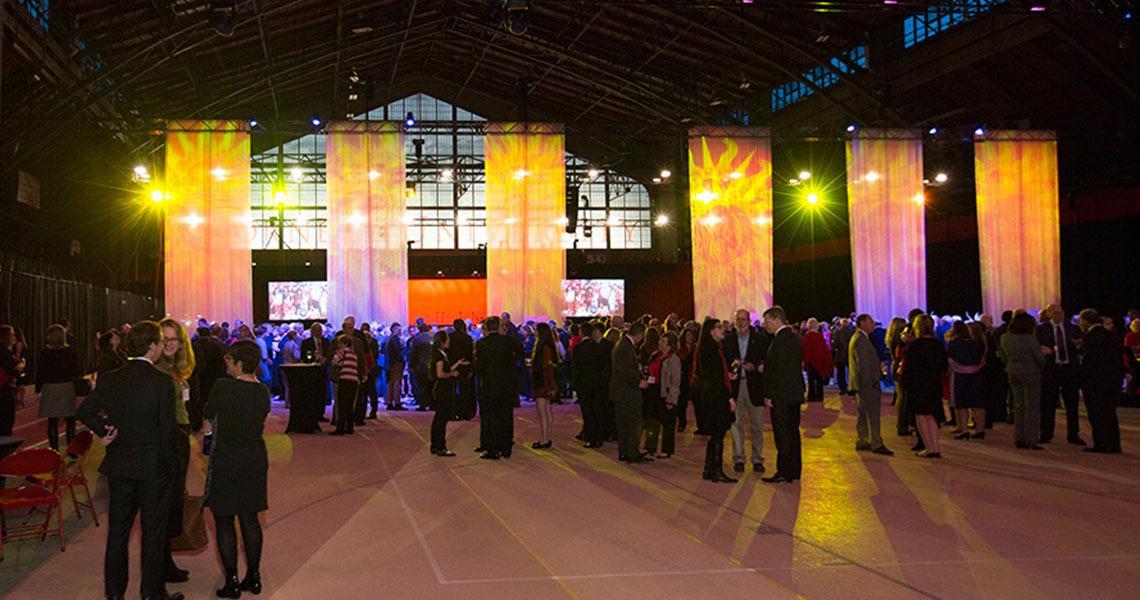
<box><xmin>203</xmin><ymin>340</ymin><xmax>269</xmax><ymax>598</ymax></box>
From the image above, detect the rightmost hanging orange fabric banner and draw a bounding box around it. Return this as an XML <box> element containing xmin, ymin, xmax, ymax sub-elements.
<box><xmin>974</xmin><ymin>131</ymin><xmax>1061</xmax><ymax>316</ymax></box>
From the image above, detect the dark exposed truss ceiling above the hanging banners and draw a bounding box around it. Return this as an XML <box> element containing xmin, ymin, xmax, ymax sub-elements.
<box><xmin>0</xmin><ymin>0</ymin><xmax>1140</xmax><ymax>186</ymax></box>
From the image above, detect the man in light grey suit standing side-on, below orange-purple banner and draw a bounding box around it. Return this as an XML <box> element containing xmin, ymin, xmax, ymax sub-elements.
<box><xmin>847</xmin><ymin>314</ymin><xmax>894</xmax><ymax>456</ymax></box>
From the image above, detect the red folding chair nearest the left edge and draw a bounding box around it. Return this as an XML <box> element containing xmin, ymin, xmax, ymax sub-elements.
<box><xmin>0</xmin><ymin>448</ymin><xmax>67</xmax><ymax>560</ymax></box>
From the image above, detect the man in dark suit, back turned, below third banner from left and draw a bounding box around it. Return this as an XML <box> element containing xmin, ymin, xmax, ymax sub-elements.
<box><xmin>474</xmin><ymin>317</ymin><xmax>523</xmax><ymax>461</ymax></box>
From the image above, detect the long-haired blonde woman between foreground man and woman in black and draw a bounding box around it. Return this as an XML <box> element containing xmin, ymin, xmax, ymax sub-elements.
<box><xmin>154</xmin><ymin>318</ymin><xmax>198</xmax><ymax>583</ymax></box>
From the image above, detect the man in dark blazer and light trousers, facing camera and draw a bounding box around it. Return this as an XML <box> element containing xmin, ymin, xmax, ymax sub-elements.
<box><xmin>724</xmin><ymin>308</ymin><xmax>770</xmax><ymax>473</ymax></box>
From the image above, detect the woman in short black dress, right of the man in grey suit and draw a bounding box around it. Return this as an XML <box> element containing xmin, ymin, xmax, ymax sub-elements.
<box><xmin>902</xmin><ymin>315</ymin><xmax>950</xmax><ymax>459</ymax></box>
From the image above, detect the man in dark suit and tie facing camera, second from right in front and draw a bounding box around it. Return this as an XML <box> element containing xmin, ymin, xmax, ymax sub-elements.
<box><xmin>1037</xmin><ymin>305</ymin><xmax>1085</xmax><ymax>446</ymax></box>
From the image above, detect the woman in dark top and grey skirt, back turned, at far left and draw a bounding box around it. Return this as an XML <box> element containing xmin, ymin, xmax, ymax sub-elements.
<box><xmin>35</xmin><ymin>324</ymin><xmax>83</xmax><ymax>451</ymax></box>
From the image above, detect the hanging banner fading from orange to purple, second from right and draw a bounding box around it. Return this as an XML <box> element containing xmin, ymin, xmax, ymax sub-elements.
<box><xmin>847</xmin><ymin>129</ymin><xmax>927</xmax><ymax>323</ymax></box>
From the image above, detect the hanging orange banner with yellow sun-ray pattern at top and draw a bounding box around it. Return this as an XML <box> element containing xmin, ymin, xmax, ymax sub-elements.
<box><xmin>689</xmin><ymin>127</ymin><xmax>772</xmax><ymax>319</ymax></box>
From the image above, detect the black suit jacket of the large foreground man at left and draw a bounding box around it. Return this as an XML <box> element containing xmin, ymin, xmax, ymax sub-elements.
<box><xmin>75</xmin><ymin>359</ymin><xmax>181</xmax><ymax>479</ymax></box>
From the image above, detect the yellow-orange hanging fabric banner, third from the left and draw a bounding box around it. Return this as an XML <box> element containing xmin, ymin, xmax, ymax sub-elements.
<box><xmin>485</xmin><ymin>123</ymin><xmax>565</xmax><ymax>323</ymax></box>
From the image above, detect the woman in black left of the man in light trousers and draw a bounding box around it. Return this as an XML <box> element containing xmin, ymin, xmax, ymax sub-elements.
<box><xmin>695</xmin><ymin>317</ymin><xmax>736</xmax><ymax>484</ymax></box>
